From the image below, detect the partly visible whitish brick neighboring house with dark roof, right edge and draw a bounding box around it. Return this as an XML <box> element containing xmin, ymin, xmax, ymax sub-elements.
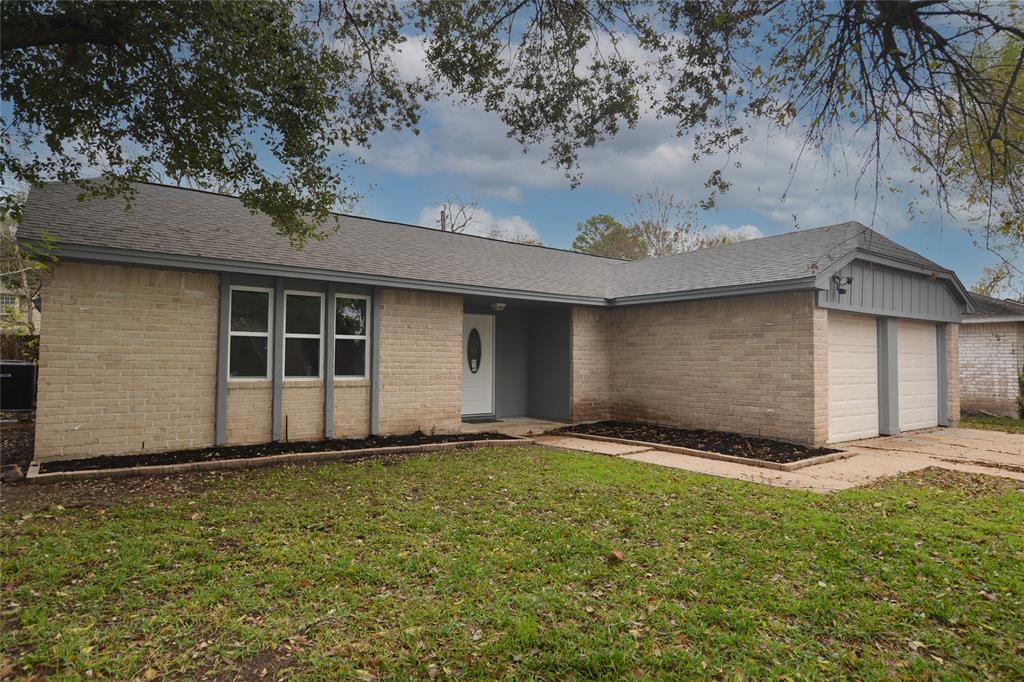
<box><xmin>959</xmin><ymin>294</ymin><xmax>1024</xmax><ymax>417</ymax></box>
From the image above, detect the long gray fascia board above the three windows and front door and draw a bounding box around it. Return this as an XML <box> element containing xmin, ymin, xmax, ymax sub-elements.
<box><xmin>44</xmin><ymin>241</ymin><xmax>607</xmax><ymax>305</ymax></box>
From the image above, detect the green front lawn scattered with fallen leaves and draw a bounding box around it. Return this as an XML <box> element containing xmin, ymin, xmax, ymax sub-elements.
<box><xmin>6</xmin><ymin>449</ymin><xmax>1024</xmax><ymax>680</ymax></box>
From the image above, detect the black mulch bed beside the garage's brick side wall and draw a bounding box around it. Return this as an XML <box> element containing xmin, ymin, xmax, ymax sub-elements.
<box><xmin>559</xmin><ymin>422</ymin><xmax>840</xmax><ymax>464</ymax></box>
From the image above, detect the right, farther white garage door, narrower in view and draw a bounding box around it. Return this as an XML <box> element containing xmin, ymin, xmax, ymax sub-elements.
<box><xmin>897</xmin><ymin>319</ymin><xmax>939</xmax><ymax>431</ymax></box>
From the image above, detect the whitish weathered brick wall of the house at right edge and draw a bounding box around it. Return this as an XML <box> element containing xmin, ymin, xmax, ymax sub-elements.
<box><xmin>950</xmin><ymin>323</ymin><xmax>1024</xmax><ymax>417</ymax></box>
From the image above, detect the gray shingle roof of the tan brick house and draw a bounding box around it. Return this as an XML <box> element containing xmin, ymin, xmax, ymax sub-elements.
<box><xmin>18</xmin><ymin>183</ymin><xmax>954</xmax><ymax>298</ymax></box>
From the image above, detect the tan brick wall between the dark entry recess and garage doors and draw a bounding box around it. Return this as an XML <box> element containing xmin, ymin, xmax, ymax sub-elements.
<box><xmin>572</xmin><ymin>292</ymin><xmax>827</xmax><ymax>443</ymax></box>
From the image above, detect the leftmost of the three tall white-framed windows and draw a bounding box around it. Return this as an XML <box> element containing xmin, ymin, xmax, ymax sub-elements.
<box><xmin>227</xmin><ymin>287</ymin><xmax>271</xmax><ymax>379</ymax></box>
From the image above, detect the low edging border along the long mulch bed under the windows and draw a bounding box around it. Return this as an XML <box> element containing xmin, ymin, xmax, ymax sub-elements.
<box><xmin>25</xmin><ymin>436</ymin><xmax>534</xmax><ymax>483</ymax></box>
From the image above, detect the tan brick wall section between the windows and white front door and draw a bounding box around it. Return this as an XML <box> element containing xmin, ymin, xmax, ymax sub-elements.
<box><xmin>380</xmin><ymin>289</ymin><xmax>463</xmax><ymax>434</ymax></box>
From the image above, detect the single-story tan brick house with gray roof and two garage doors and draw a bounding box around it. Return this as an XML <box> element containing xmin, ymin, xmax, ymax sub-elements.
<box><xmin>22</xmin><ymin>184</ymin><xmax>973</xmax><ymax>460</ymax></box>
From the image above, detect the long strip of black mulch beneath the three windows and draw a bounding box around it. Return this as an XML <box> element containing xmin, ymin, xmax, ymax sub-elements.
<box><xmin>39</xmin><ymin>431</ymin><xmax>514</xmax><ymax>473</ymax></box>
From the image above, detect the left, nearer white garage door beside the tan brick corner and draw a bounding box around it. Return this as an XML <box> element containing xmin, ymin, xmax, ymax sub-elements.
<box><xmin>828</xmin><ymin>311</ymin><xmax>879</xmax><ymax>442</ymax></box>
